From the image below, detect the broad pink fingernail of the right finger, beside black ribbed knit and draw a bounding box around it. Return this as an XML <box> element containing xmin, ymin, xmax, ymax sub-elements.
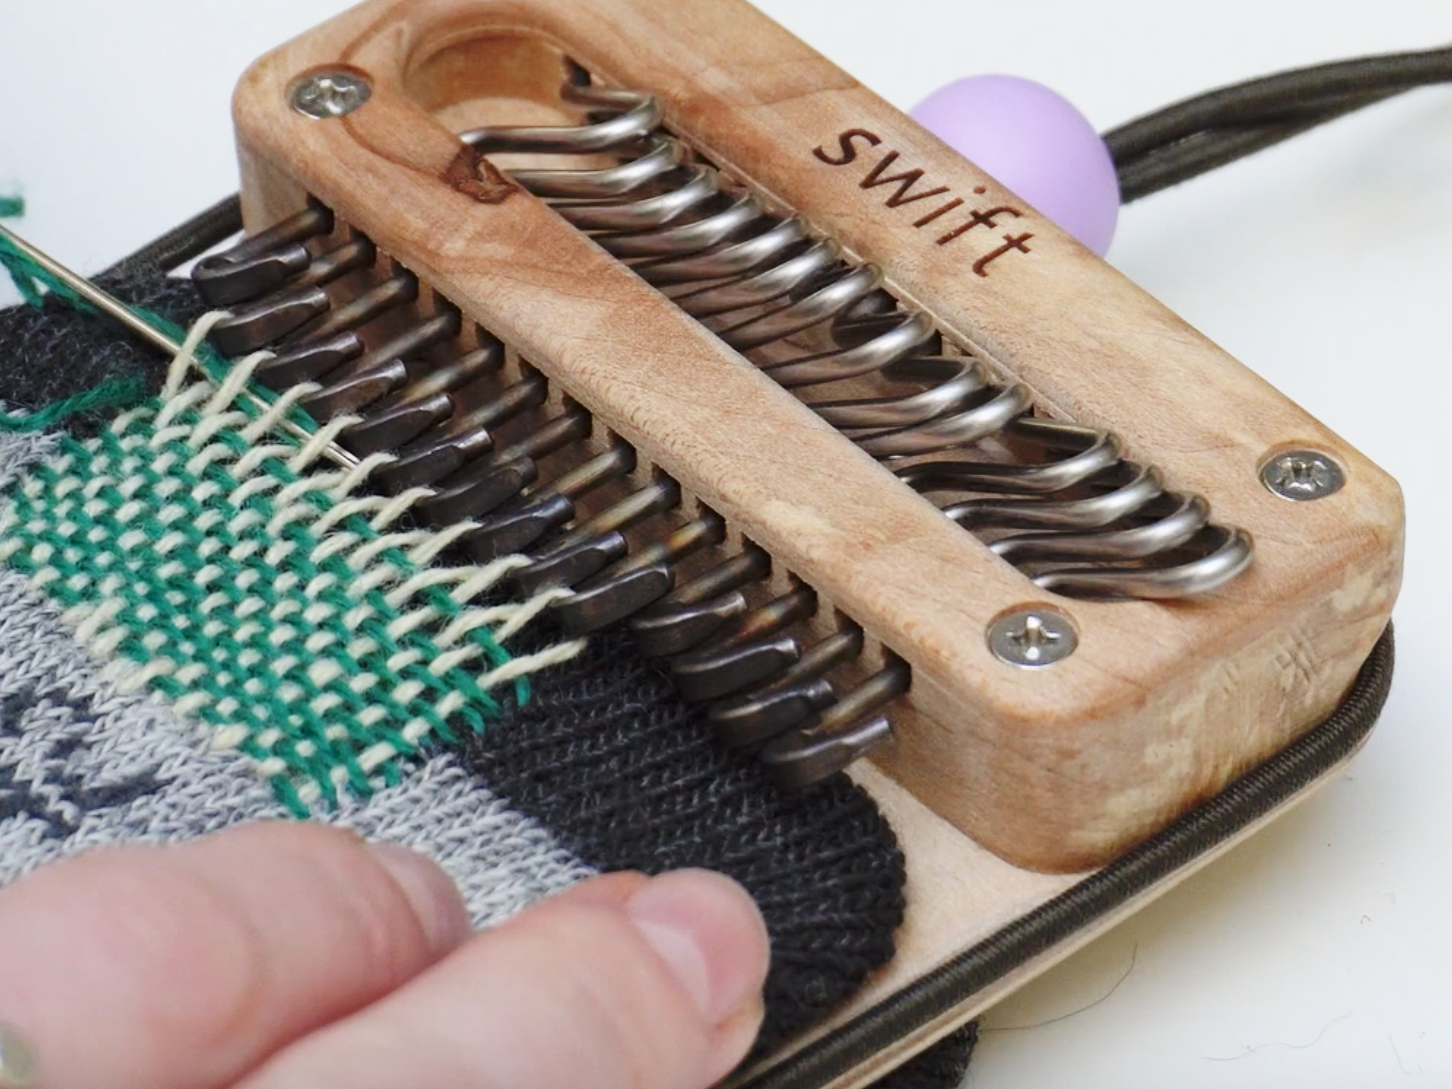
<box><xmin>626</xmin><ymin>870</ymin><xmax>768</xmax><ymax>1025</ymax></box>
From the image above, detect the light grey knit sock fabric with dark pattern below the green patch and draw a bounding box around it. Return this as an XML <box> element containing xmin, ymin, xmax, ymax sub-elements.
<box><xmin>0</xmin><ymin>563</ymin><xmax>595</xmax><ymax>926</ymax></box>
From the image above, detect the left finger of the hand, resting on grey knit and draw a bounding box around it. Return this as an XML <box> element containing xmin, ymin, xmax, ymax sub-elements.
<box><xmin>0</xmin><ymin>823</ymin><xmax>469</xmax><ymax>1089</ymax></box>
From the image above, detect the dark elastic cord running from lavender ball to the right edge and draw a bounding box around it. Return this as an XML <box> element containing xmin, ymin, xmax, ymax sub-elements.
<box><xmin>1104</xmin><ymin>48</ymin><xmax>1452</xmax><ymax>203</ymax></box>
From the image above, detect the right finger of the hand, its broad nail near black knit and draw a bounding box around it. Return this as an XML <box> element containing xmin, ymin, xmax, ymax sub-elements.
<box><xmin>238</xmin><ymin>871</ymin><xmax>768</xmax><ymax>1089</ymax></box>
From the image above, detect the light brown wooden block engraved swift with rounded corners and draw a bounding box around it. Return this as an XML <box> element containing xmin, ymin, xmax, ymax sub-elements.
<box><xmin>235</xmin><ymin>0</ymin><xmax>1403</xmax><ymax>873</ymax></box>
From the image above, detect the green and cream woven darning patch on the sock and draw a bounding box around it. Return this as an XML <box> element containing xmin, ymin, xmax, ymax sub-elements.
<box><xmin>0</xmin><ymin>336</ymin><xmax>579</xmax><ymax>815</ymax></box>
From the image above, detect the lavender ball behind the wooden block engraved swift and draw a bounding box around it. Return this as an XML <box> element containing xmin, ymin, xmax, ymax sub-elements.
<box><xmin>912</xmin><ymin>76</ymin><xmax>1119</xmax><ymax>257</ymax></box>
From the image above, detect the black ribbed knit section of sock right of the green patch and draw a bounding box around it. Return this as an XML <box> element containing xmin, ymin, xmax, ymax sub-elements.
<box><xmin>463</xmin><ymin>621</ymin><xmax>903</xmax><ymax>1048</ymax></box>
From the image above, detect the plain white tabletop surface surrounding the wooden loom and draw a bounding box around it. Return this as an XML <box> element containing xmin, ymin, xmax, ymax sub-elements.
<box><xmin>0</xmin><ymin>0</ymin><xmax>1452</xmax><ymax>1089</ymax></box>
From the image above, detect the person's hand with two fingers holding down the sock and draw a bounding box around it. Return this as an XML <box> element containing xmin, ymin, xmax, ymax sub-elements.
<box><xmin>0</xmin><ymin>823</ymin><xmax>767</xmax><ymax>1089</ymax></box>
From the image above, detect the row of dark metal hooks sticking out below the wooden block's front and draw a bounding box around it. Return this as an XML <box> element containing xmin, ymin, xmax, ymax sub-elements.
<box><xmin>193</xmin><ymin>205</ymin><xmax>910</xmax><ymax>787</ymax></box>
